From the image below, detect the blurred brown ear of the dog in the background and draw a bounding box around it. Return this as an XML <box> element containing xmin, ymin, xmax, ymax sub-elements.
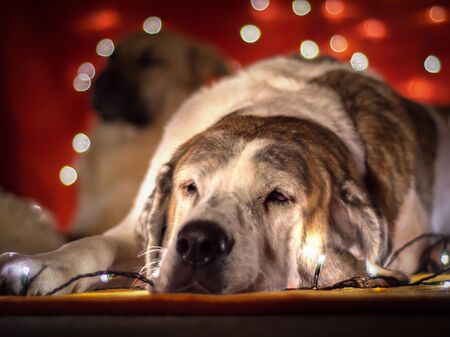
<box><xmin>189</xmin><ymin>45</ymin><xmax>230</xmax><ymax>87</ymax></box>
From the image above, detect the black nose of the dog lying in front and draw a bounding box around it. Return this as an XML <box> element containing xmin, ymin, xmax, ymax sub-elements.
<box><xmin>177</xmin><ymin>220</ymin><xmax>233</xmax><ymax>265</ymax></box>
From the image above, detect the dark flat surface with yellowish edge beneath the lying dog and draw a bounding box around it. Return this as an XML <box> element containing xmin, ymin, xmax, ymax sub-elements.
<box><xmin>0</xmin><ymin>275</ymin><xmax>450</xmax><ymax>337</ymax></box>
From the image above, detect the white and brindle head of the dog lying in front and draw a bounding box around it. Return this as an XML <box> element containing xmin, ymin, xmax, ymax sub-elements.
<box><xmin>143</xmin><ymin>113</ymin><xmax>383</xmax><ymax>294</ymax></box>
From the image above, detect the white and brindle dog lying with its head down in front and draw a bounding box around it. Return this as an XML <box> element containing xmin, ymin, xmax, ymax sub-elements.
<box><xmin>0</xmin><ymin>57</ymin><xmax>450</xmax><ymax>295</ymax></box>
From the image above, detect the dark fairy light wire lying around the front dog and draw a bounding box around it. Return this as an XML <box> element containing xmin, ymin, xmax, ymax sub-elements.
<box><xmin>45</xmin><ymin>233</ymin><xmax>450</xmax><ymax>296</ymax></box>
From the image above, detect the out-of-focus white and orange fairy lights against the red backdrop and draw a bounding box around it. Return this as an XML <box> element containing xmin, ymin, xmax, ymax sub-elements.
<box><xmin>59</xmin><ymin>0</ymin><xmax>448</xmax><ymax>186</ymax></box>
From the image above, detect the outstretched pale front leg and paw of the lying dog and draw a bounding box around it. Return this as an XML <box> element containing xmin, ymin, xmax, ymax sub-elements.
<box><xmin>0</xmin><ymin>220</ymin><xmax>140</xmax><ymax>295</ymax></box>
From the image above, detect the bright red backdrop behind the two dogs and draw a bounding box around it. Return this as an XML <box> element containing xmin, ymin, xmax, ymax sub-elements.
<box><xmin>0</xmin><ymin>0</ymin><xmax>450</xmax><ymax>228</ymax></box>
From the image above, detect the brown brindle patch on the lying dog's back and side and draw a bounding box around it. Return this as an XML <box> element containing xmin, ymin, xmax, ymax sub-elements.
<box><xmin>312</xmin><ymin>70</ymin><xmax>436</xmax><ymax>228</ymax></box>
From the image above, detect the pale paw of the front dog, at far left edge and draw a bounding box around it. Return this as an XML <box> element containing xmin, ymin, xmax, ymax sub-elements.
<box><xmin>0</xmin><ymin>253</ymin><xmax>87</xmax><ymax>296</ymax></box>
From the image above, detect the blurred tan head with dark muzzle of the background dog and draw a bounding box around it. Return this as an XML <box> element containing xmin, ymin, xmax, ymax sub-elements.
<box><xmin>92</xmin><ymin>31</ymin><xmax>228</xmax><ymax>126</ymax></box>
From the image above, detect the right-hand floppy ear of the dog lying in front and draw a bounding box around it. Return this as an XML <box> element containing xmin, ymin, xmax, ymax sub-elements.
<box><xmin>331</xmin><ymin>179</ymin><xmax>388</xmax><ymax>265</ymax></box>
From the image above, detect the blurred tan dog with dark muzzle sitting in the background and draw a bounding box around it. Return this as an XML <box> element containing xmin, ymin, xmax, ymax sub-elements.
<box><xmin>71</xmin><ymin>31</ymin><xmax>228</xmax><ymax>237</ymax></box>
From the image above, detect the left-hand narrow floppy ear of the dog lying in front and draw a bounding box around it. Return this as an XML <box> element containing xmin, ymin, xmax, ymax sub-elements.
<box><xmin>140</xmin><ymin>163</ymin><xmax>173</xmax><ymax>255</ymax></box>
